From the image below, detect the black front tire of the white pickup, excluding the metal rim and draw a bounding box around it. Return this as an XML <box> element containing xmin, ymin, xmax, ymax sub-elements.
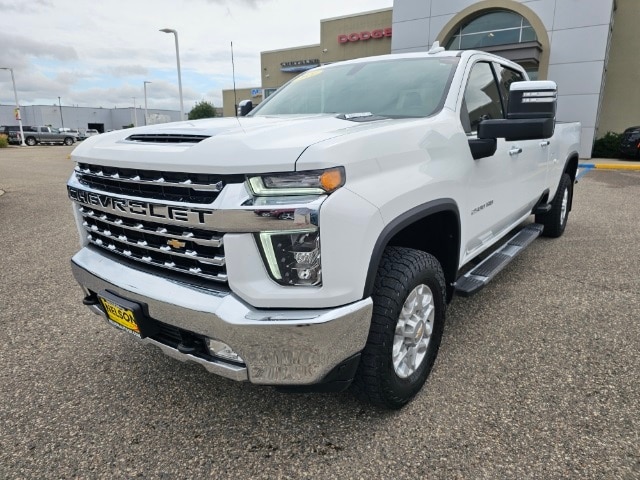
<box><xmin>352</xmin><ymin>247</ymin><xmax>446</xmax><ymax>409</ymax></box>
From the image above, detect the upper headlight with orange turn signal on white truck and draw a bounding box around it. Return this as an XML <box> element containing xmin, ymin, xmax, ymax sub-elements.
<box><xmin>247</xmin><ymin>167</ymin><xmax>345</xmax><ymax>197</ymax></box>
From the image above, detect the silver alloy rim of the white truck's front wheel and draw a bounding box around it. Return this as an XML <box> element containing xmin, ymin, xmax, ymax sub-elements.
<box><xmin>392</xmin><ymin>284</ymin><xmax>435</xmax><ymax>378</ymax></box>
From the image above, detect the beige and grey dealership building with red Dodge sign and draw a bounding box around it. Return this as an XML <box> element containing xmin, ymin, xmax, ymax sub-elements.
<box><xmin>223</xmin><ymin>0</ymin><xmax>640</xmax><ymax>158</ymax></box>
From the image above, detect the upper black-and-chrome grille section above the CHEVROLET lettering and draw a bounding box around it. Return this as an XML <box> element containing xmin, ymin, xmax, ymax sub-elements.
<box><xmin>75</xmin><ymin>163</ymin><xmax>244</xmax><ymax>204</ymax></box>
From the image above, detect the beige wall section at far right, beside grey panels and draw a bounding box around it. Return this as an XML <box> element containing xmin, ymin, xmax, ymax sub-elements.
<box><xmin>596</xmin><ymin>0</ymin><xmax>640</xmax><ymax>138</ymax></box>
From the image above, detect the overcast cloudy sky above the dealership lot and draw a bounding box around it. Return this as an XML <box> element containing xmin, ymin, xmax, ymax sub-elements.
<box><xmin>0</xmin><ymin>0</ymin><xmax>393</xmax><ymax>112</ymax></box>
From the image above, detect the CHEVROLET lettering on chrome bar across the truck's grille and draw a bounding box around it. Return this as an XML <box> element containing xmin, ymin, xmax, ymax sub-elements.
<box><xmin>67</xmin><ymin>187</ymin><xmax>214</xmax><ymax>225</ymax></box>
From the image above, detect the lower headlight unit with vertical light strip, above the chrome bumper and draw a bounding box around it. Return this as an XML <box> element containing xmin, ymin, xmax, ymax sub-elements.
<box><xmin>256</xmin><ymin>230</ymin><xmax>322</xmax><ymax>286</ymax></box>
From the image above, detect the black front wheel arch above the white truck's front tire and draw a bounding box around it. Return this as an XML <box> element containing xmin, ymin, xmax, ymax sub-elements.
<box><xmin>363</xmin><ymin>198</ymin><xmax>461</xmax><ymax>302</ymax></box>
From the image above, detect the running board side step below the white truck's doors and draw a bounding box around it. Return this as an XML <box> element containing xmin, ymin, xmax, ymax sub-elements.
<box><xmin>454</xmin><ymin>223</ymin><xmax>544</xmax><ymax>297</ymax></box>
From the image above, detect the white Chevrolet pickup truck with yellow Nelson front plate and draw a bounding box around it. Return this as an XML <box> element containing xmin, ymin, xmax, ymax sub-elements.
<box><xmin>67</xmin><ymin>46</ymin><xmax>580</xmax><ymax>409</ymax></box>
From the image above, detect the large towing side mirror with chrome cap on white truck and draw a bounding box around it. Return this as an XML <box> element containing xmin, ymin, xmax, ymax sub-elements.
<box><xmin>478</xmin><ymin>80</ymin><xmax>558</xmax><ymax>141</ymax></box>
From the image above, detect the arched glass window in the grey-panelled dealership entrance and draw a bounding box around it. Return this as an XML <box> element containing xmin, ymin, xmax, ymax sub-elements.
<box><xmin>446</xmin><ymin>10</ymin><xmax>538</xmax><ymax>50</ymax></box>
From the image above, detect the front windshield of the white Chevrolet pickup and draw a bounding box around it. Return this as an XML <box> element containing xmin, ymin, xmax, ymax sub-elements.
<box><xmin>250</xmin><ymin>57</ymin><xmax>458</xmax><ymax>118</ymax></box>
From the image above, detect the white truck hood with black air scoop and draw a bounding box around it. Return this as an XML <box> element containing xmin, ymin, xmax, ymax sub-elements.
<box><xmin>71</xmin><ymin>114</ymin><xmax>393</xmax><ymax>174</ymax></box>
